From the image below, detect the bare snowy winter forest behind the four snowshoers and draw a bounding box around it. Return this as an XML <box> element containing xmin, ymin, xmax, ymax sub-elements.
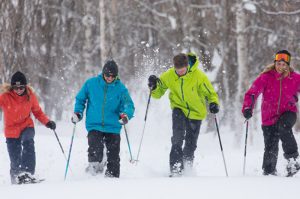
<box><xmin>0</xmin><ymin>0</ymin><xmax>300</xmax><ymax>143</ymax></box>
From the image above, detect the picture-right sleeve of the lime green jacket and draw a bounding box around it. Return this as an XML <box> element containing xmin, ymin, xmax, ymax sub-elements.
<box><xmin>200</xmin><ymin>73</ymin><xmax>219</xmax><ymax>104</ymax></box>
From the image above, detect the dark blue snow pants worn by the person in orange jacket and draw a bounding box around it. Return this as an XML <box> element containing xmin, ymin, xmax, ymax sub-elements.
<box><xmin>6</xmin><ymin>127</ymin><xmax>35</xmax><ymax>184</ymax></box>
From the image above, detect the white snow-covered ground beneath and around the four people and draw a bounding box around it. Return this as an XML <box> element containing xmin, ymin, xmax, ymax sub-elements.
<box><xmin>0</xmin><ymin>96</ymin><xmax>300</xmax><ymax>199</ymax></box>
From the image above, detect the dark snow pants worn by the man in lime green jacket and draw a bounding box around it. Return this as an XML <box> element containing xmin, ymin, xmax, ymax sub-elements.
<box><xmin>170</xmin><ymin>108</ymin><xmax>201</xmax><ymax>172</ymax></box>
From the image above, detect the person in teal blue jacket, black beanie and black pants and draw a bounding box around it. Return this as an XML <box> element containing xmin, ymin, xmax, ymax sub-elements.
<box><xmin>71</xmin><ymin>60</ymin><xmax>135</xmax><ymax>177</ymax></box>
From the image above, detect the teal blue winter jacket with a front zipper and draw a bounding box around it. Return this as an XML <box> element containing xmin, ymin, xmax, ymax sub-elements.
<box><xmin>74</xmin><ymin>74</ymin><xmax>134</xmax><ymax>134</ymax></box>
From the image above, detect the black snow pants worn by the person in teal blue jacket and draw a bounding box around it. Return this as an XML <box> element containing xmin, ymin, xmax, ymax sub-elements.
<box><xmin>88</xmin><ymin>130</ymin><xmax>121</xmax><ymax>178</ymax></box>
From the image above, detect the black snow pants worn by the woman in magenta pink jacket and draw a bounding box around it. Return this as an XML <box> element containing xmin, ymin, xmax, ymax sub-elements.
<box><xmin>262</xmin><ymin>112</ymin><xmax>299</xmax><ymax>174</ymax></box>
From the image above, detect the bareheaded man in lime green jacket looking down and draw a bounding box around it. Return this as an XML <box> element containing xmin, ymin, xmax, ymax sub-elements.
<box><xmin>148</xmin><ymin>53</ymin><xmax>219</xmax><ymax>177</ymax></box>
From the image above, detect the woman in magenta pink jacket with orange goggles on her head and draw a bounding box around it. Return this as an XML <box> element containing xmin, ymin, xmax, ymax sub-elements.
<box><xmin>242</xmin><ymin>50</ymin><xmax>300</xmax><ymax>176</ymax></box>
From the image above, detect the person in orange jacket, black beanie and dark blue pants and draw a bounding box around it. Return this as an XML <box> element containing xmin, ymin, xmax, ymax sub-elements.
<box><xmin>0</xmin><ymin>71</ymin><xmax>56</xmax><ymax>184</ymax></box>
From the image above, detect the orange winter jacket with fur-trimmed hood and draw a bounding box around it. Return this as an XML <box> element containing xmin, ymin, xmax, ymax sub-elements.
<box><xmin>0</xmin><ymin>87</ymin><xmax>49</xmax><ymax>138</ymax></box>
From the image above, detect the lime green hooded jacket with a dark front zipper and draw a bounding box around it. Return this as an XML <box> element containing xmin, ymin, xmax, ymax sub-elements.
<box><xmin>151</xmin><ymin>53</ymin><xmax>219</xmax><ymax>120</ymax></box>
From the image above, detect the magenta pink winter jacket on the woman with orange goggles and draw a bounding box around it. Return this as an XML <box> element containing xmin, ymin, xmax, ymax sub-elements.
<box><xmin>242</xmin><ymin>70</ymin><xmax>300</xmax><ymax>126</ymax></box>
